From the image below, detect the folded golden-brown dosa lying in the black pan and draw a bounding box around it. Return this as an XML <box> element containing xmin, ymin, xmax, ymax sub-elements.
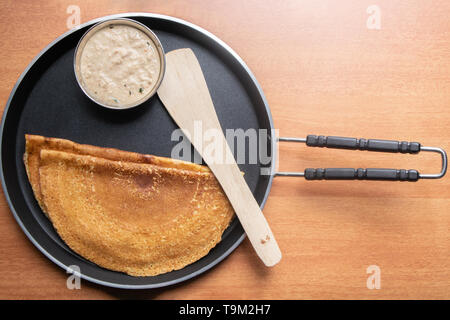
<box><xmin>24</xmin><ymin>135</ymin><xmax>234</xmax><ymax>276</ymax></box>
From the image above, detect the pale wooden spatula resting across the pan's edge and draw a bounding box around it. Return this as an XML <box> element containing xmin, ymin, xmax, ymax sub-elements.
<box><xmin>158</xmin><ymin>49</ymin><xmax>281</xmax><ymax>266</ymax></box>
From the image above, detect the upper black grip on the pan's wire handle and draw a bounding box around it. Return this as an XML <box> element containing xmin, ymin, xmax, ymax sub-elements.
<box><xmin>306</xmin><ymin>135</ymin><xmax>420</xmax><ymax>153</ymax></box>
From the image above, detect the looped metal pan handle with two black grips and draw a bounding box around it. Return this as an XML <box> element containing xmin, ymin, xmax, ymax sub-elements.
<box><xmin>275</xmin><ymin>135</ymin><xmax>447</xmax><ymax>181</ymax></box>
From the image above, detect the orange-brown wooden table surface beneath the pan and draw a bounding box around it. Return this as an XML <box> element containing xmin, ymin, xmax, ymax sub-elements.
<box><xmin>0</xmin><ymin>0</ymin><xmax>450</xmax><ymax>299</ymax></box>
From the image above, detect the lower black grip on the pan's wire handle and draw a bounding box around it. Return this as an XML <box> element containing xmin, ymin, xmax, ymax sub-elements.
<box><xmin>305</xmin><ymin>168</ymin><xmax>419</xmax><ymax>181</ymax></box>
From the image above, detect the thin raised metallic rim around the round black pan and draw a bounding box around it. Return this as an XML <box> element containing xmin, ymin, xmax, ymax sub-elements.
<box><xmin>0</xmin><ymin>12</ymin><xmax>277</xmax><ymax>289</ymax></box>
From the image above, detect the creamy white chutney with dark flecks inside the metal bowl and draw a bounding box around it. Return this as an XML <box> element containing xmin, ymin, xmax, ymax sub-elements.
<box><xmin>79</xmin><ymin>24</ymin><xmax>161</xmax><ymax>108</ymax></box>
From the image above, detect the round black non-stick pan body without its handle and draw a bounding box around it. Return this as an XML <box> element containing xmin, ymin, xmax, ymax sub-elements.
<box><xmin>0</xmin><ymin>13</ymin><xmax>275</xmax><ymax>289</ymax></box>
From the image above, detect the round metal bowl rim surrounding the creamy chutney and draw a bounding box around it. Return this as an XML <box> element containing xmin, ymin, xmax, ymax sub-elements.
<box><xmin>73</xmin><ymin>18</ymin><xmax>166</xmax><ymax>110</ymax></box>
